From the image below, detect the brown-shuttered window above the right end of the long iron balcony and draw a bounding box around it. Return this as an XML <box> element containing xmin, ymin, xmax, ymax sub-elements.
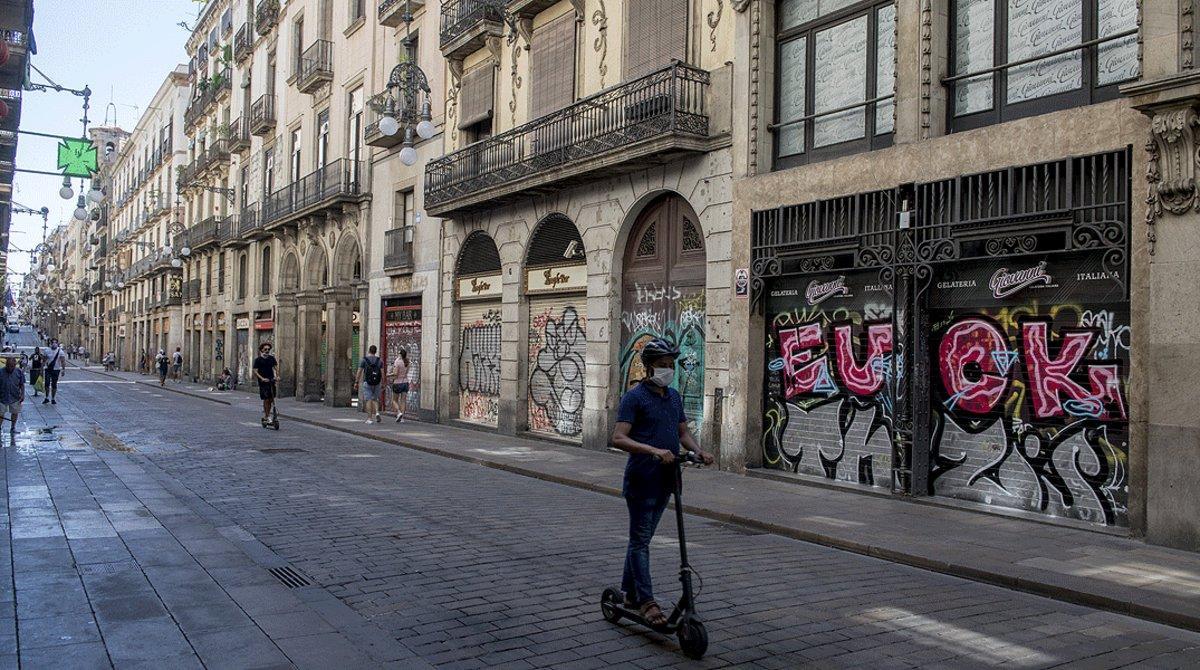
<box><xmin>625</xmin><ymin>0</ymin><xmax>689</xmax><ymax>80</ymax></box>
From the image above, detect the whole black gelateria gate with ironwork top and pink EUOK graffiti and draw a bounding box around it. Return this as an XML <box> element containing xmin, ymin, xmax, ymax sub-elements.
<box><xmin>751</xmin><ymin>149</ymin><xmax>1134</xmax><ymax>526</ymax></box>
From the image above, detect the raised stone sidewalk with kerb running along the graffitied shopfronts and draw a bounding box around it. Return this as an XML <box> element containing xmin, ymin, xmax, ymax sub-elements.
<box><xmin>94</xmin><ymin>369</ymin><xmax>1200</xmax><ymax>630</ymax></box>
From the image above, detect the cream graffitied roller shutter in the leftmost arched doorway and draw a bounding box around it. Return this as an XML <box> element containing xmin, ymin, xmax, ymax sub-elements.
<box><xmin>458</xmin><ymin>300</ymin><xmax>500</xmax><ymax>426</ymax></box>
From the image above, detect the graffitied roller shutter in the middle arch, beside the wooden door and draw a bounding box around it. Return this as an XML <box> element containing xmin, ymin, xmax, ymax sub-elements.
<box><xmin>528</xmin><ymin>293</ymin><xmax>588</xmax><ymax>441</ymax></box>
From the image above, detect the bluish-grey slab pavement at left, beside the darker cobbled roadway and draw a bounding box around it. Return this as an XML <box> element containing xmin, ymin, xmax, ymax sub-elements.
<box><xmin>0</xmin><ymin>397</ymin><xmax>428</xmax><ymax>669</ymax></box>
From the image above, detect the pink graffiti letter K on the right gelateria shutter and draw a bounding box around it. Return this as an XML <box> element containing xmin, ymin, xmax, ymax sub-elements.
<box><xmin>1021</xmin><ymin>321</ymin><xmax>1128</xmax><ymax>420</ymax></box>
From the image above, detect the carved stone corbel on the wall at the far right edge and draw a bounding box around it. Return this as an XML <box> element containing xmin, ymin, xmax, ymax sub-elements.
<box><xmin>1146</xmin><ymin>106</ymin><xmax>1200</xmax><ymax>255</ymax></box>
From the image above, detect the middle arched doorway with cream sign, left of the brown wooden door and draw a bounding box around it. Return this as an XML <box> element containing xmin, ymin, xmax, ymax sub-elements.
<box><xmin>524</xmin><ymin>214</ymin><xmax>588</xmax><ymax>439</ymax></box>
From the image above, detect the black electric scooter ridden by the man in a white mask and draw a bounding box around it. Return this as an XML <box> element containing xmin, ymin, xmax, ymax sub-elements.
<box><xmin>600</xmin><ymin>453</ymin><xmax>708</xmax><ymax>659</ymax></box>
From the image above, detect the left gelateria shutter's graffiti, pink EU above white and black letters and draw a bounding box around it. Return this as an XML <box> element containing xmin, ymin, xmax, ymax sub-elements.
<box><xmin>763</xmin><ymin>275</ymin><xmax>902</xmax><ymax>486</ymax></box>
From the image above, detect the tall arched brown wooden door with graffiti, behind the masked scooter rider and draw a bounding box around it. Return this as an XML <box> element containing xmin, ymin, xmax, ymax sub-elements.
<box><xmin>619</xmin><ymin>193</ymin><xmax>706</xmax><ymax>435</ymax></box>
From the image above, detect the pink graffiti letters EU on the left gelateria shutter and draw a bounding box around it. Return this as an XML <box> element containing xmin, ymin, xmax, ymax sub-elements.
<box><xmin>779</xmin><ymin>322</ymin><xmax>892</xmax><ymax>399</ymax></box>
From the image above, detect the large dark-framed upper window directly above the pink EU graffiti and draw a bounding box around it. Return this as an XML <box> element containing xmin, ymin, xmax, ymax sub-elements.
<box><xmin>772</xmin><ymin>0</ymin><xmax>896</xmax><ymax>168</ymax></box>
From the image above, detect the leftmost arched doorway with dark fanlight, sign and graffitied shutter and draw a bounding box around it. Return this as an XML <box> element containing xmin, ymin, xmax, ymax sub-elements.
<box><xmin>455</xmin><ymin>231</ymin><xmax>504</xmax><ymax>426</ymax></box>
